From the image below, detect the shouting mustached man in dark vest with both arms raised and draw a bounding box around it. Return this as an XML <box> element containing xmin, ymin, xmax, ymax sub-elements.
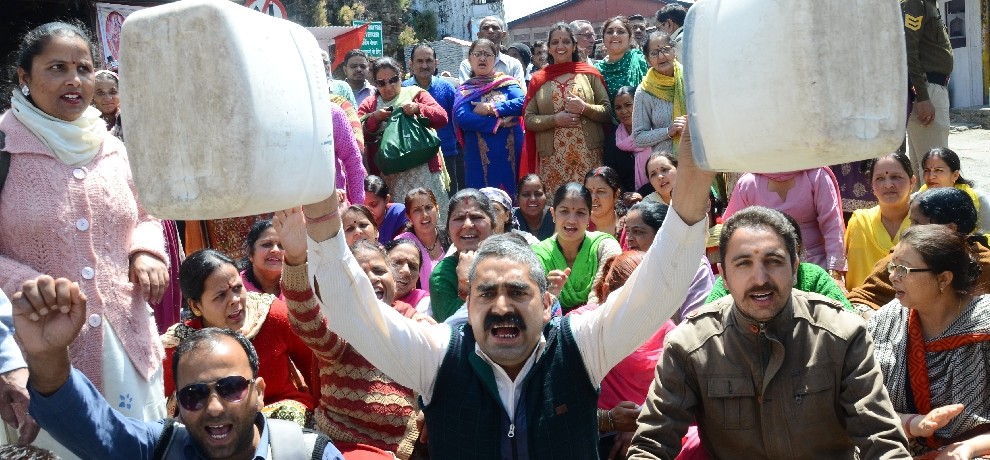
<box><xmin>275</xmin><ymin>123</ymin><xmax>714</xmax><ymax>459</ymax></box>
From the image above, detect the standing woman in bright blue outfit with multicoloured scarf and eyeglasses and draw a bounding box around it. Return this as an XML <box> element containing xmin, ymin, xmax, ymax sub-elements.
<box><xmin>453</xmin><ymin>38</ymin><xmax>526</xmax><ymax>195</ymax></box>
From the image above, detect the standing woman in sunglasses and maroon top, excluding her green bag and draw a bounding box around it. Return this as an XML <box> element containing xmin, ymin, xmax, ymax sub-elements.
<box><xmin>358</xmin><ymin>57</ymin><xmax>450</xmax><ymax>224</ymax></box>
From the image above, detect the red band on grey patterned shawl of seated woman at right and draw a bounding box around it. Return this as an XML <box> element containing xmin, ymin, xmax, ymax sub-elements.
<box><xmin>907</xmin><ymin>309</ymin><xmax>990</xmax><ymax>449</ymax></box>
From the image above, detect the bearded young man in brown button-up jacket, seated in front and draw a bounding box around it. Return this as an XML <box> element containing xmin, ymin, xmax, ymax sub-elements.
<box><xmin>629</xmin><ymin>206</ymin><xmax>911</xmax><ymax>459</ymax></box>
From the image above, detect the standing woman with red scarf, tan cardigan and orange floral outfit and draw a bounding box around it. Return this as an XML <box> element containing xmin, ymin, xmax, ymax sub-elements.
<box><xmin>522</xmin><ymin>22</ymin><xmax>612</xmax><ymax>198</ymax></box>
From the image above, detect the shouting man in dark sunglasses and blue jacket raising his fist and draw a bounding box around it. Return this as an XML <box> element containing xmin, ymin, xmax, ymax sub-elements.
<box><xmin>12</xmin><ymin>276</ymin><xmax>343</xmax><ymax>460</ymax></box>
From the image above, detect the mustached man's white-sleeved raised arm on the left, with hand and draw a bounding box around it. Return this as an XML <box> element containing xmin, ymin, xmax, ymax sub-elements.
<box><xmin>273</xmin><ymin>201</ymin><xmax>451</xmax><ymax>398</ymax></box>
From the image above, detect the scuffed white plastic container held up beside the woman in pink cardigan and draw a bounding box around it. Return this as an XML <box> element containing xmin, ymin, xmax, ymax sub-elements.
<box><xmin>120</xmin><ymin>0</ymin><xmax>335</xmax><ymax>220</ymax></box>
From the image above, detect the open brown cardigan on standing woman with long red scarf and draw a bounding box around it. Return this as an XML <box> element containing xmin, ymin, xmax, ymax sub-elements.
<box><xmin>525</xmin><ymin>74</ymin><xmax>613</xmax><ymax>157</ymax></box>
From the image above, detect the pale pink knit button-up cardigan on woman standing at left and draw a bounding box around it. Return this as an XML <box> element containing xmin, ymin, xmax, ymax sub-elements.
<box><xmin>0</xmin><ymin>111</ymin><xmax>168</xmax><ymax>389</ymax></box>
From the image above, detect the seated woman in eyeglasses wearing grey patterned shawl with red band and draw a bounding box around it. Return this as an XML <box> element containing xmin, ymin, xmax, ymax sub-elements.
<box><xmin>867</xmin><ymin>225</ymin><xmax>990</xmax><ymax>458</ymax></box>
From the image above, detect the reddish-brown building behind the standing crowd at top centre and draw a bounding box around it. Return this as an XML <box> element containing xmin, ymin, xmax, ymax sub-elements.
<box><xmin>509</xmin><ymin>0</ymin><xmax>666</xmax><ymax>43</ymax></box>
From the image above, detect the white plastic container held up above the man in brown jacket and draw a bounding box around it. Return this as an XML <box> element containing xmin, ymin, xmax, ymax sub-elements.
<box><xmin>683</xmin><ymin>0</ymin><xmax>908</xmax><ymax>172</ymax></box>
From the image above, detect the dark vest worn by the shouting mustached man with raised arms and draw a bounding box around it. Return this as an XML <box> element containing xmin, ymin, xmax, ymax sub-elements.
<box><xmin>424</xmin><ymin>318</ymin><xmax>598</xmax><ymax>460</ymax></box>
